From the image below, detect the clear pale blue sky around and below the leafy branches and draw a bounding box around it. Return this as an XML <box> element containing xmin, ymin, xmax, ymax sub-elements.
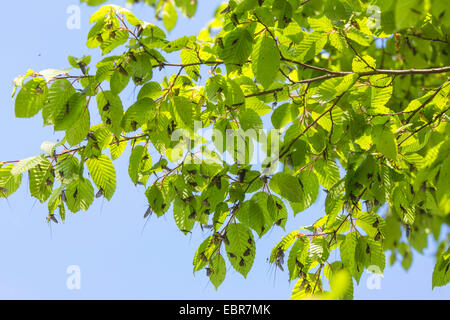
<box><xmin>0</xmin><ymin>0</ymin><xmax>450</xmax><ymax>299</ymax></box>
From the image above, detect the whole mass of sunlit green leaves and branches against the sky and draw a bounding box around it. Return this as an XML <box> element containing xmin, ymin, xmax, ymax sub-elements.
<box><xmin>0</xmin><ymin>0</ymin><xmax>450</xmax><ymax>299</ymax></box>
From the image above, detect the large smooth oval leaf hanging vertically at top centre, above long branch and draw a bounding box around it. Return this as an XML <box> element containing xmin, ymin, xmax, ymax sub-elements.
<box><xmin>251</xmin><ymin>35</ymin><xmax>280</xmax><ymax>88</ymax></box>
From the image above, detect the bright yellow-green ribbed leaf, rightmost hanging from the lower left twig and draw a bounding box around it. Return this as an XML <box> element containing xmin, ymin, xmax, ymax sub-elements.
<box><xmin>86</xmin><ymin>154</ymin><xmax>116</xmax><ymax>200</ymax></box>
